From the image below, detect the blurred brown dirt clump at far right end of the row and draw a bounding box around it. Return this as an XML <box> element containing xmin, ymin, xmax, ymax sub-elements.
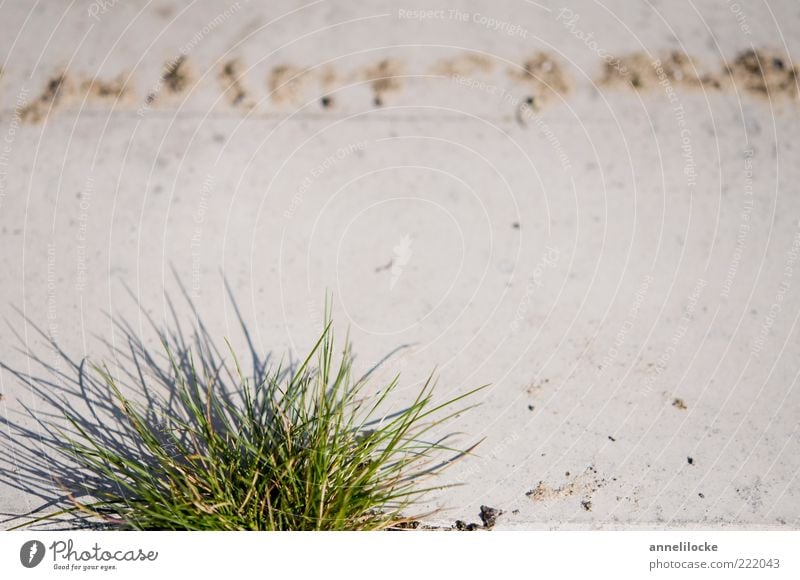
<box><xmin>727</xmin><ymin>49</ymin><xmax>798</xmax><ymax>98</ymax></box>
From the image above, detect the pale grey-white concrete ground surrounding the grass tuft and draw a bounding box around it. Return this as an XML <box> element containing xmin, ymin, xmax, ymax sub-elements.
<box><xmin>0</xmin><ymin>0</ymin><xmax>800</xmax><ymax>529</ymax></box>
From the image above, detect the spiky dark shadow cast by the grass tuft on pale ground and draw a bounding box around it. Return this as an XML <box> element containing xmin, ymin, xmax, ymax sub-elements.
<box><xmin>0</xmin><ymin>284</ymin><xmax>288</xmax><ymax>529</ymax></box>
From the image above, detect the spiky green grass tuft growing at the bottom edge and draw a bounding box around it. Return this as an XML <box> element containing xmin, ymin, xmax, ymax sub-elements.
<box><xmin>28</xmin><ymin>321</ymin><xmax>479</xmax><ymax>530</ymax></box>
